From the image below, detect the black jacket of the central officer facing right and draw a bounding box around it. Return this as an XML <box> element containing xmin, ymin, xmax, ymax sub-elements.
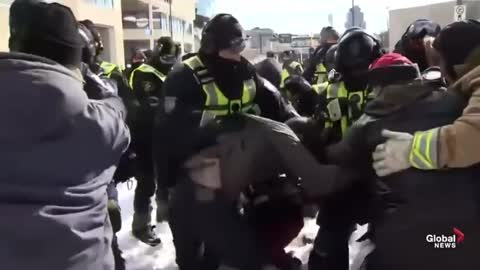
<box><xmin>154</xmin><ymin>54</ymin><xmax>298</xmax><ymax>189</ymax></box>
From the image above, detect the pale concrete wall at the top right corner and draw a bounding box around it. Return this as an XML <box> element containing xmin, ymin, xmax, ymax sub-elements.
<box><xmin>389</xmin><ymin>0</ymin><xmax>480</xmax><ymax>50</ymax></box>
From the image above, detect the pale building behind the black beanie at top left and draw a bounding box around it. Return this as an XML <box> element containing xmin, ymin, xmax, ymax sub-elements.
<box><xmin>0</xmin><ymin>0</ymin><xmax>125</xmax><ymax>65</ymax></box>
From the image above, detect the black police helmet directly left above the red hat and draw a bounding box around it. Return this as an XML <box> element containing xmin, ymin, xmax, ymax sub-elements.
<box><xmin>335</xmin><ymin>30</ymin><xmax>383</xmax><ymax>73</ymax></box>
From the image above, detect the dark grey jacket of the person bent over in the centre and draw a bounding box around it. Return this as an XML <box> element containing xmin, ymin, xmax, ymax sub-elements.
<box><xmin>185</xmin><ymin>115</ymin><xmax>353</xmax><ymax>199</ymax></box>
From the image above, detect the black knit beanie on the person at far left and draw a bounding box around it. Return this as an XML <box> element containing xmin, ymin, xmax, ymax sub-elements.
<box><xmin>10</xmin><ymin>0</ymin><xmax>83</xmax><ymax>67</ymax></box>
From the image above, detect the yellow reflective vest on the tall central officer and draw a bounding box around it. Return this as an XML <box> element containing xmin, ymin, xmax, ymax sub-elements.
<box><xmin>183</xmin><ymin>56</ymin><xmax>259</xmax><ymax>126</ymax></box>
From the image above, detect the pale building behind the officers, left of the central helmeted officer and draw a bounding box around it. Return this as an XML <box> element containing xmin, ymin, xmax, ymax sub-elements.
<box><xmin>121</xmin><ymin>0</ymin><xmax>196</xmax><ymax>61</ymax></box>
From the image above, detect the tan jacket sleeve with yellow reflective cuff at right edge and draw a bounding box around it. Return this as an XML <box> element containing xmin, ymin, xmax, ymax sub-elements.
<box><xmin>410</xmin><ymin>63</ymin><xmax>480</xmax><ymax>169</ymax></box>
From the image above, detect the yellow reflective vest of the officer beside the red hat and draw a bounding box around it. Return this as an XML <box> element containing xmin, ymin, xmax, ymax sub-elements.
<box><xmin>325</xmin><ymin>82</ymin><xmax>366</xmax><ymax>136</ymax></box>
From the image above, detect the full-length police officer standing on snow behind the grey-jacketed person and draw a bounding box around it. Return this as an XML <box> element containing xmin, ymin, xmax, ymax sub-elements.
<box><xmin>129</xmin><ymin>37</ymin><xmax>178</xmax><ymax>246</ymax></box>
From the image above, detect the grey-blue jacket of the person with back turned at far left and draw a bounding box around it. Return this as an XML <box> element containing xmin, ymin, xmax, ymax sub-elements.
<box><xmin>0</xmin><ymin>53</ymin><xmax>130</xmax><ymax>270</ymax></box>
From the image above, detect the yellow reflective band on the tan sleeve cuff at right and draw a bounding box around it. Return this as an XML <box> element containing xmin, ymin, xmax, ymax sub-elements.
<box><xmin>409</xmin><ymin>128</ymin><xmax>440</xmax><ymax>170</ymax></box>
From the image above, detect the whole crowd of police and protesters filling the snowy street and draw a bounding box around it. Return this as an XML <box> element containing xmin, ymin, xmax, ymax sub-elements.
<box><xmin>0</xmin><ymin>0</ymin><xmax>480</xmax><ymax>270</ymax></box>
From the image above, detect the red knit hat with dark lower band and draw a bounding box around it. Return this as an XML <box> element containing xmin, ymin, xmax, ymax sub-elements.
<box><xmin>369</xmin><ymin>53</ymin><xmax>421</xmax><ymax>85</ymax></box>
